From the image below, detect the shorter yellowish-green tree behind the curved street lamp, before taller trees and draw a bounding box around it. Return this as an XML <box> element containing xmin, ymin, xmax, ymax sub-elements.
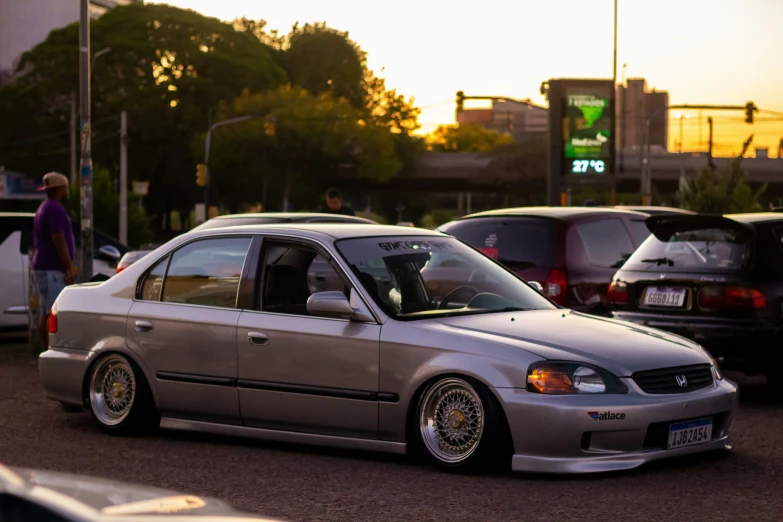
<box><xmin>202</xmin><ymin>87</ymin><xmax>402</xmax><ymax>209</ymax></box>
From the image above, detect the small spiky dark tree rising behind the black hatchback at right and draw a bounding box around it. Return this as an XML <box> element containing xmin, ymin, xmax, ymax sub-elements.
<box><xmin>678</xmin><ymin>157</ymin><xmax>767</xmax><ymax>214</ymax></box>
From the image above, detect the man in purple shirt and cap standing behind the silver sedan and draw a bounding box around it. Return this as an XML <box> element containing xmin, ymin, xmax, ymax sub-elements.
<box><xmin>32</xmin><ymin>172</ymin><xmax>76</xmax><ymax>345</ymax></box>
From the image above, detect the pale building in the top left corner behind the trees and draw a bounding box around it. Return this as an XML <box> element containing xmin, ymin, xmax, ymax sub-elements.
<box><xmin>0</xmin><ymin>0</ymin><xmax>143</xmax><ymax>73</ymax></box>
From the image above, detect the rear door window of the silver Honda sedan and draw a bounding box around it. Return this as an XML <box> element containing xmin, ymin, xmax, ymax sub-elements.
<box><xmin>163</xmin><ymin>237</ymin><xmax>250</xmax><ymax>308</ymax></box>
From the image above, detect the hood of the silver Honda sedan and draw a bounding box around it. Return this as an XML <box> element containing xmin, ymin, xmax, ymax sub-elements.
<box><xmin>422</xmin><ymin>310</ymin><xmax>710</xmax><ymax>377</ymax></box>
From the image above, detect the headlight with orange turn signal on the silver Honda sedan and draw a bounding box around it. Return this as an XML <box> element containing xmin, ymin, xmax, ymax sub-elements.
<box><xmin>527</xmin><ymin>361</ymin><xmax>628</xmax><ymax>395</ymax></box>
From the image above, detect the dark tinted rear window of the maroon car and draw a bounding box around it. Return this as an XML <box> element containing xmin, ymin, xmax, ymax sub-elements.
<box><xmin>441</xmin><ymin>218</ymin><xmax>557</xmax><ymax>270</ymax></box>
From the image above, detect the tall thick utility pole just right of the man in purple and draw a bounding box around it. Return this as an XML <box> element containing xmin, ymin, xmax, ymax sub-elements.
<box><xmin>79</xmin><ymin>0</ymin><xmax>93</xmax><ymax>281</ymax></box>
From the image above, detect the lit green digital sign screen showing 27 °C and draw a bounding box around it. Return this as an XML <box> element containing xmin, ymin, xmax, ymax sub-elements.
<box><xmin>563</xmin><ymin>94</ymin><xmax>614</xmax><ymax>174</ymax></box>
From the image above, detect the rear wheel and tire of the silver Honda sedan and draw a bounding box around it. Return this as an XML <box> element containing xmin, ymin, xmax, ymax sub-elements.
<box><xmin>87</xmin><ymin>354</ymin><xmax>157</xmax><ymax>435</ymax></box>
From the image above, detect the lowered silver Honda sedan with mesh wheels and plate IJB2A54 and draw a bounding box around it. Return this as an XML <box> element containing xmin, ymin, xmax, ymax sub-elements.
<box><xmin>39</xmin><ymin>224</ymin><xmax>737</xmax><ymax>473</ymax></box>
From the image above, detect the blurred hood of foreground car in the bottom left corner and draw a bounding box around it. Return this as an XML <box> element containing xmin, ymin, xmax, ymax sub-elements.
<box><xmin>0</xmin><ymin>465</ymin><xmax>282</xmax><ymax>522</ymax></box>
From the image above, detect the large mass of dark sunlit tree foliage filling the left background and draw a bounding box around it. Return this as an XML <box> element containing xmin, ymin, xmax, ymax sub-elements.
<box><xmin>0</xmin><ymin>4</ymin><xmax>422</xmax><ymax>232</ymax></box>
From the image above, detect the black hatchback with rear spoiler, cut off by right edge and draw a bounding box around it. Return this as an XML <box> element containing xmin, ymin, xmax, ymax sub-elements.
<box><xmin>610</xmin><ymin>212</ymin><xmax>783</xmax><ymax>389</ymax></box>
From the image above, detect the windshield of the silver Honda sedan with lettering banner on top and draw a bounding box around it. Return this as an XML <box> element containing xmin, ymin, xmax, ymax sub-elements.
<box><xmin>337</xmin><ymin>236</ymin><xmax>556</xmax><ymax>320</ymax></box>
